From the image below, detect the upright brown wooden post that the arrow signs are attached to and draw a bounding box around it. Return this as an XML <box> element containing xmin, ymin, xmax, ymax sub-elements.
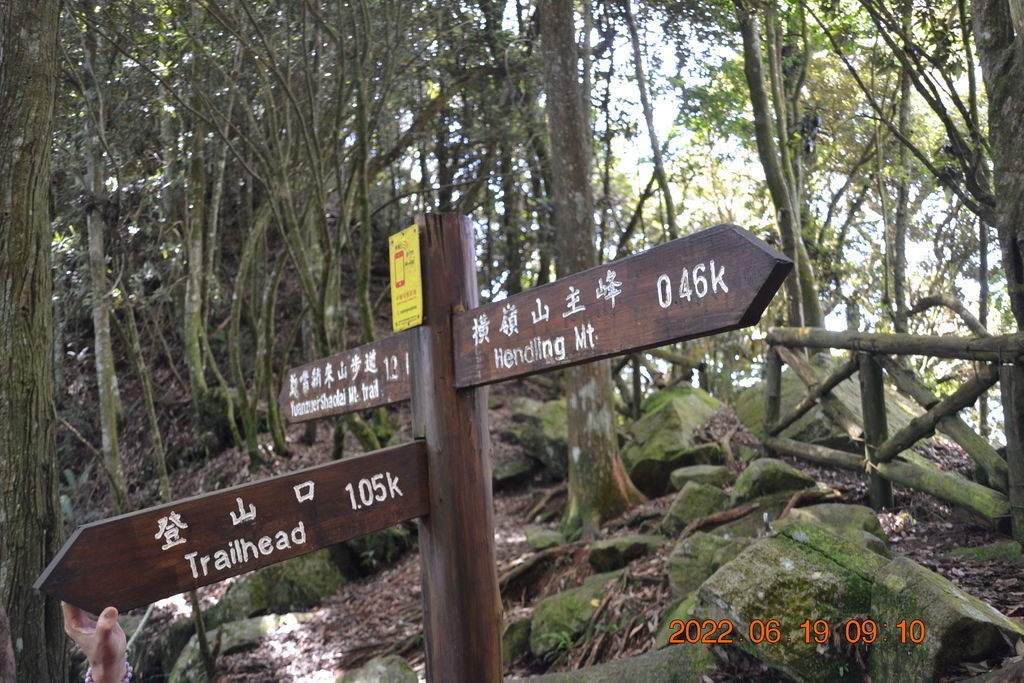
<box><xmin>410</xmin><ymin>214</ymin><xmax>502</xmax><ymax>683</ymax></box>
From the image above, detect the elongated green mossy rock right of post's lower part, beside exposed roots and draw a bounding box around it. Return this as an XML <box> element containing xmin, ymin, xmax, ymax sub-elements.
<box><xmin>529</xmin><ymin>571</ymin><xmax>622</xmax><ymax>659</ymax></box>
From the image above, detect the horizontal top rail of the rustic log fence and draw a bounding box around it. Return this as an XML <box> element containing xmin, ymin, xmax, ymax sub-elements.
<box><xmin>768</xmin><ymin>328</ymin><xmax>1024</xmax><ymax>362</ymax></box>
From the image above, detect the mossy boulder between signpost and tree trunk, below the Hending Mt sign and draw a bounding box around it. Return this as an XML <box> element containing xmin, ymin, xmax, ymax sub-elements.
<box><xmin>505</xmin><ymin>396</ymin><xmax>568</xmax><ymax>479</ymax></box>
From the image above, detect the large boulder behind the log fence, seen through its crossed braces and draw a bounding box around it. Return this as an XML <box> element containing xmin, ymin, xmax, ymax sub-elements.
<box><xmin>735</xmin><ymin>353</ymin><xmax>922</xmax><ymax>453</ymax></box>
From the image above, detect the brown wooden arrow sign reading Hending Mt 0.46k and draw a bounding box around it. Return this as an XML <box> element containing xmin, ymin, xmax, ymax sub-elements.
<box><xmin>453</xmin><ymin>224</ymin><xmax>793</xmax><ymax>388</ymax></box>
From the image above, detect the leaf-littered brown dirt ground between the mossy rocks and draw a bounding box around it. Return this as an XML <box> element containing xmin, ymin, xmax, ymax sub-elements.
<box><xmin>116</xmin><ymin>387</ymin><xmax>1024</xmax><ymax>683</ymax></box>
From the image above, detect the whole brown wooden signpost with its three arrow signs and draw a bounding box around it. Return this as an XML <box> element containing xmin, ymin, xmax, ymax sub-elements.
<box><xmin>36</xmin><ymin>215</ymin><xmax>793</xmax><ymax>683</ymax></box>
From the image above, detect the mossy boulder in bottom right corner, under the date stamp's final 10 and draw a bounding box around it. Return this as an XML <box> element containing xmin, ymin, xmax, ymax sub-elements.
<box><xmin>869</xmin><ymin>557</ymin><xmax>1024</xmax><ymax>681</ymax></box>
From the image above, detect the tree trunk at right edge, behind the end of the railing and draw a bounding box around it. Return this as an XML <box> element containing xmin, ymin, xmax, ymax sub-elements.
<box><xmin>972</xmin><ymin>0</ymin><xmax>1024</xmax><ymax>541</ymax></box>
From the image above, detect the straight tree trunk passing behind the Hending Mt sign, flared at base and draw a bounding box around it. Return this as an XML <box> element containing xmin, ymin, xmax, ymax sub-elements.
<box><xmin>539</xmin><ymin>0</ymin><xmax>643</xmax><ymax>537</ymax></box>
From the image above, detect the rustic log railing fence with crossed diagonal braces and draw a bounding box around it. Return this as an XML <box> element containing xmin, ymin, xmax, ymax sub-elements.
<box><xmin>764</xmin><ymin>328</ymin><xmax>1024</xmax><ymax>525</ymax></box>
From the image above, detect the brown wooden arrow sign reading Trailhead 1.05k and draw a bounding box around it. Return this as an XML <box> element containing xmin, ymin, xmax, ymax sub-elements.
<box><xmin>34</xmin><ymin>441</ymin><xmax>429</xmax><ymax>614</ymax></box>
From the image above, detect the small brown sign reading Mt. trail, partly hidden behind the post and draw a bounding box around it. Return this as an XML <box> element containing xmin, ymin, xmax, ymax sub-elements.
<box><xmin>278</xmin><ymin>332</ymin><xmax>410</xmax><ymax>422</ymax></box>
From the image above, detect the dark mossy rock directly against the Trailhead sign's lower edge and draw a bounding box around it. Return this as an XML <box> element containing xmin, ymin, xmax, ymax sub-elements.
<box><xmin>205</xmin><ymin>548</ymin><xmax>345</xmax><ymax>630</ymax></box>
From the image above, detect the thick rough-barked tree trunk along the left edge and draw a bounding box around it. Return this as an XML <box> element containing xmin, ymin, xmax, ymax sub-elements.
<box><xmin>0</xmin><ymin>0</ymin><xmax>68</xmax><ymax>681</ymax></box>
